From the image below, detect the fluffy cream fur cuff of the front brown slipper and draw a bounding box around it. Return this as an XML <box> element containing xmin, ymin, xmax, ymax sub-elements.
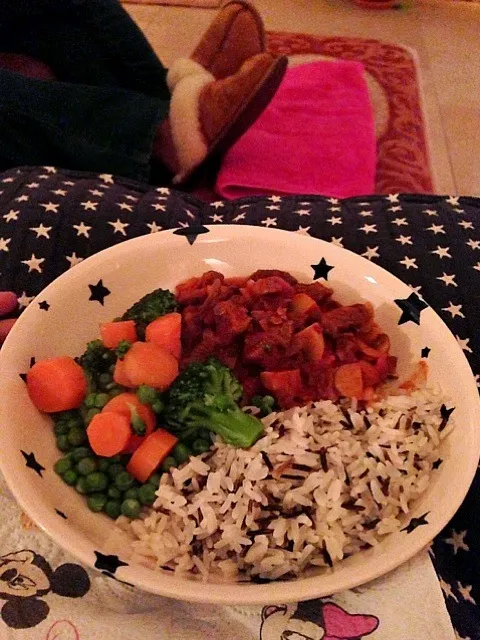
<box><xmin>169</xmin><ymin>69</ymin><xmax>215</xmax><ymax>183</ymax></box>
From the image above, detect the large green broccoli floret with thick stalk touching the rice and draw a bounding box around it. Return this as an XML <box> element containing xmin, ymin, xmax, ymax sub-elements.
<box><xmin>164</xmin><ymin>358</ymin><xmax>263</xmax><ymax>447</ymax></box>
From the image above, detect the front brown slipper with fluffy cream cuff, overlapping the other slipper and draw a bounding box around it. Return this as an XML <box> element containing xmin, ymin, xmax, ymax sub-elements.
<box><xmin>169</xmin><ymin>53</ymin><xmax>288</xmax><ymax>185</ymax></box>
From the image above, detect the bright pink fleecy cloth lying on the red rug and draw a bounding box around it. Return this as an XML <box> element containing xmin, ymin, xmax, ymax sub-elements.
<box><xmin>216</xmin><ymin>60</ymin><xmax>376</xmax><ymax>198</ymax></box>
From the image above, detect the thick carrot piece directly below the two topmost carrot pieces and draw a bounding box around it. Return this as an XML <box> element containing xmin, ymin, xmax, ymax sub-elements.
<box><xmin>123</xmin><ymin>342</ymin><xmax>178</xmax><ymax>391</ymax></box>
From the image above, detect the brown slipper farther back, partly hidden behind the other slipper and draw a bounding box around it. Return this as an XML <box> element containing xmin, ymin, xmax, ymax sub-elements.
<box><xmin>167</xmin><ymin>0</ymin><xmax>266</xmax><ymax>91</ymax></box>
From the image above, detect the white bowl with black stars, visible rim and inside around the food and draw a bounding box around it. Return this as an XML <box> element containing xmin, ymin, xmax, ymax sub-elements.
<box><xmin>0</xmin><ymin>225</ymin><xmax>480</xmax><ymax>604</ymax></box>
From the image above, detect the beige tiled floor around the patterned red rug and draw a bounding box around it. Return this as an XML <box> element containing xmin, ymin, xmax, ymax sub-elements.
<box><xmin>126</xmin><ymin>0</ymin><xmax>480</xmax><ymax>196</ymax></box>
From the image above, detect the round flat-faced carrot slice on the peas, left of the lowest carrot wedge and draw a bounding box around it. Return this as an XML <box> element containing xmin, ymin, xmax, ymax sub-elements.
<box><xmin>87</xmin><ymin>411</ymin><xmax>132</xmax><ymax>458</ymax></box>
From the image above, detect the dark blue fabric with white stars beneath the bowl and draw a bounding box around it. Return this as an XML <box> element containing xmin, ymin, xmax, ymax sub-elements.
<box><xmin>0</xmin><ymin>167</ymin><xmax>480</xmax><ymax>640</ymax></box>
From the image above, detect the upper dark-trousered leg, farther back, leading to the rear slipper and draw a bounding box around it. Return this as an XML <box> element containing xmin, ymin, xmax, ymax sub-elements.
<box><xmin>0</xmin><ymin>0</ymin><xmax>169</xmax><ymax>100</ymax></box>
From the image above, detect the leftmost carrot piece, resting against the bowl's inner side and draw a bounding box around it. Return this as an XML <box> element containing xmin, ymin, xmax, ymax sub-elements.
<box><xmin>27</xmin><ymin>356</ymin><xmax>87</xmax><ymax>413</ymax></box>
